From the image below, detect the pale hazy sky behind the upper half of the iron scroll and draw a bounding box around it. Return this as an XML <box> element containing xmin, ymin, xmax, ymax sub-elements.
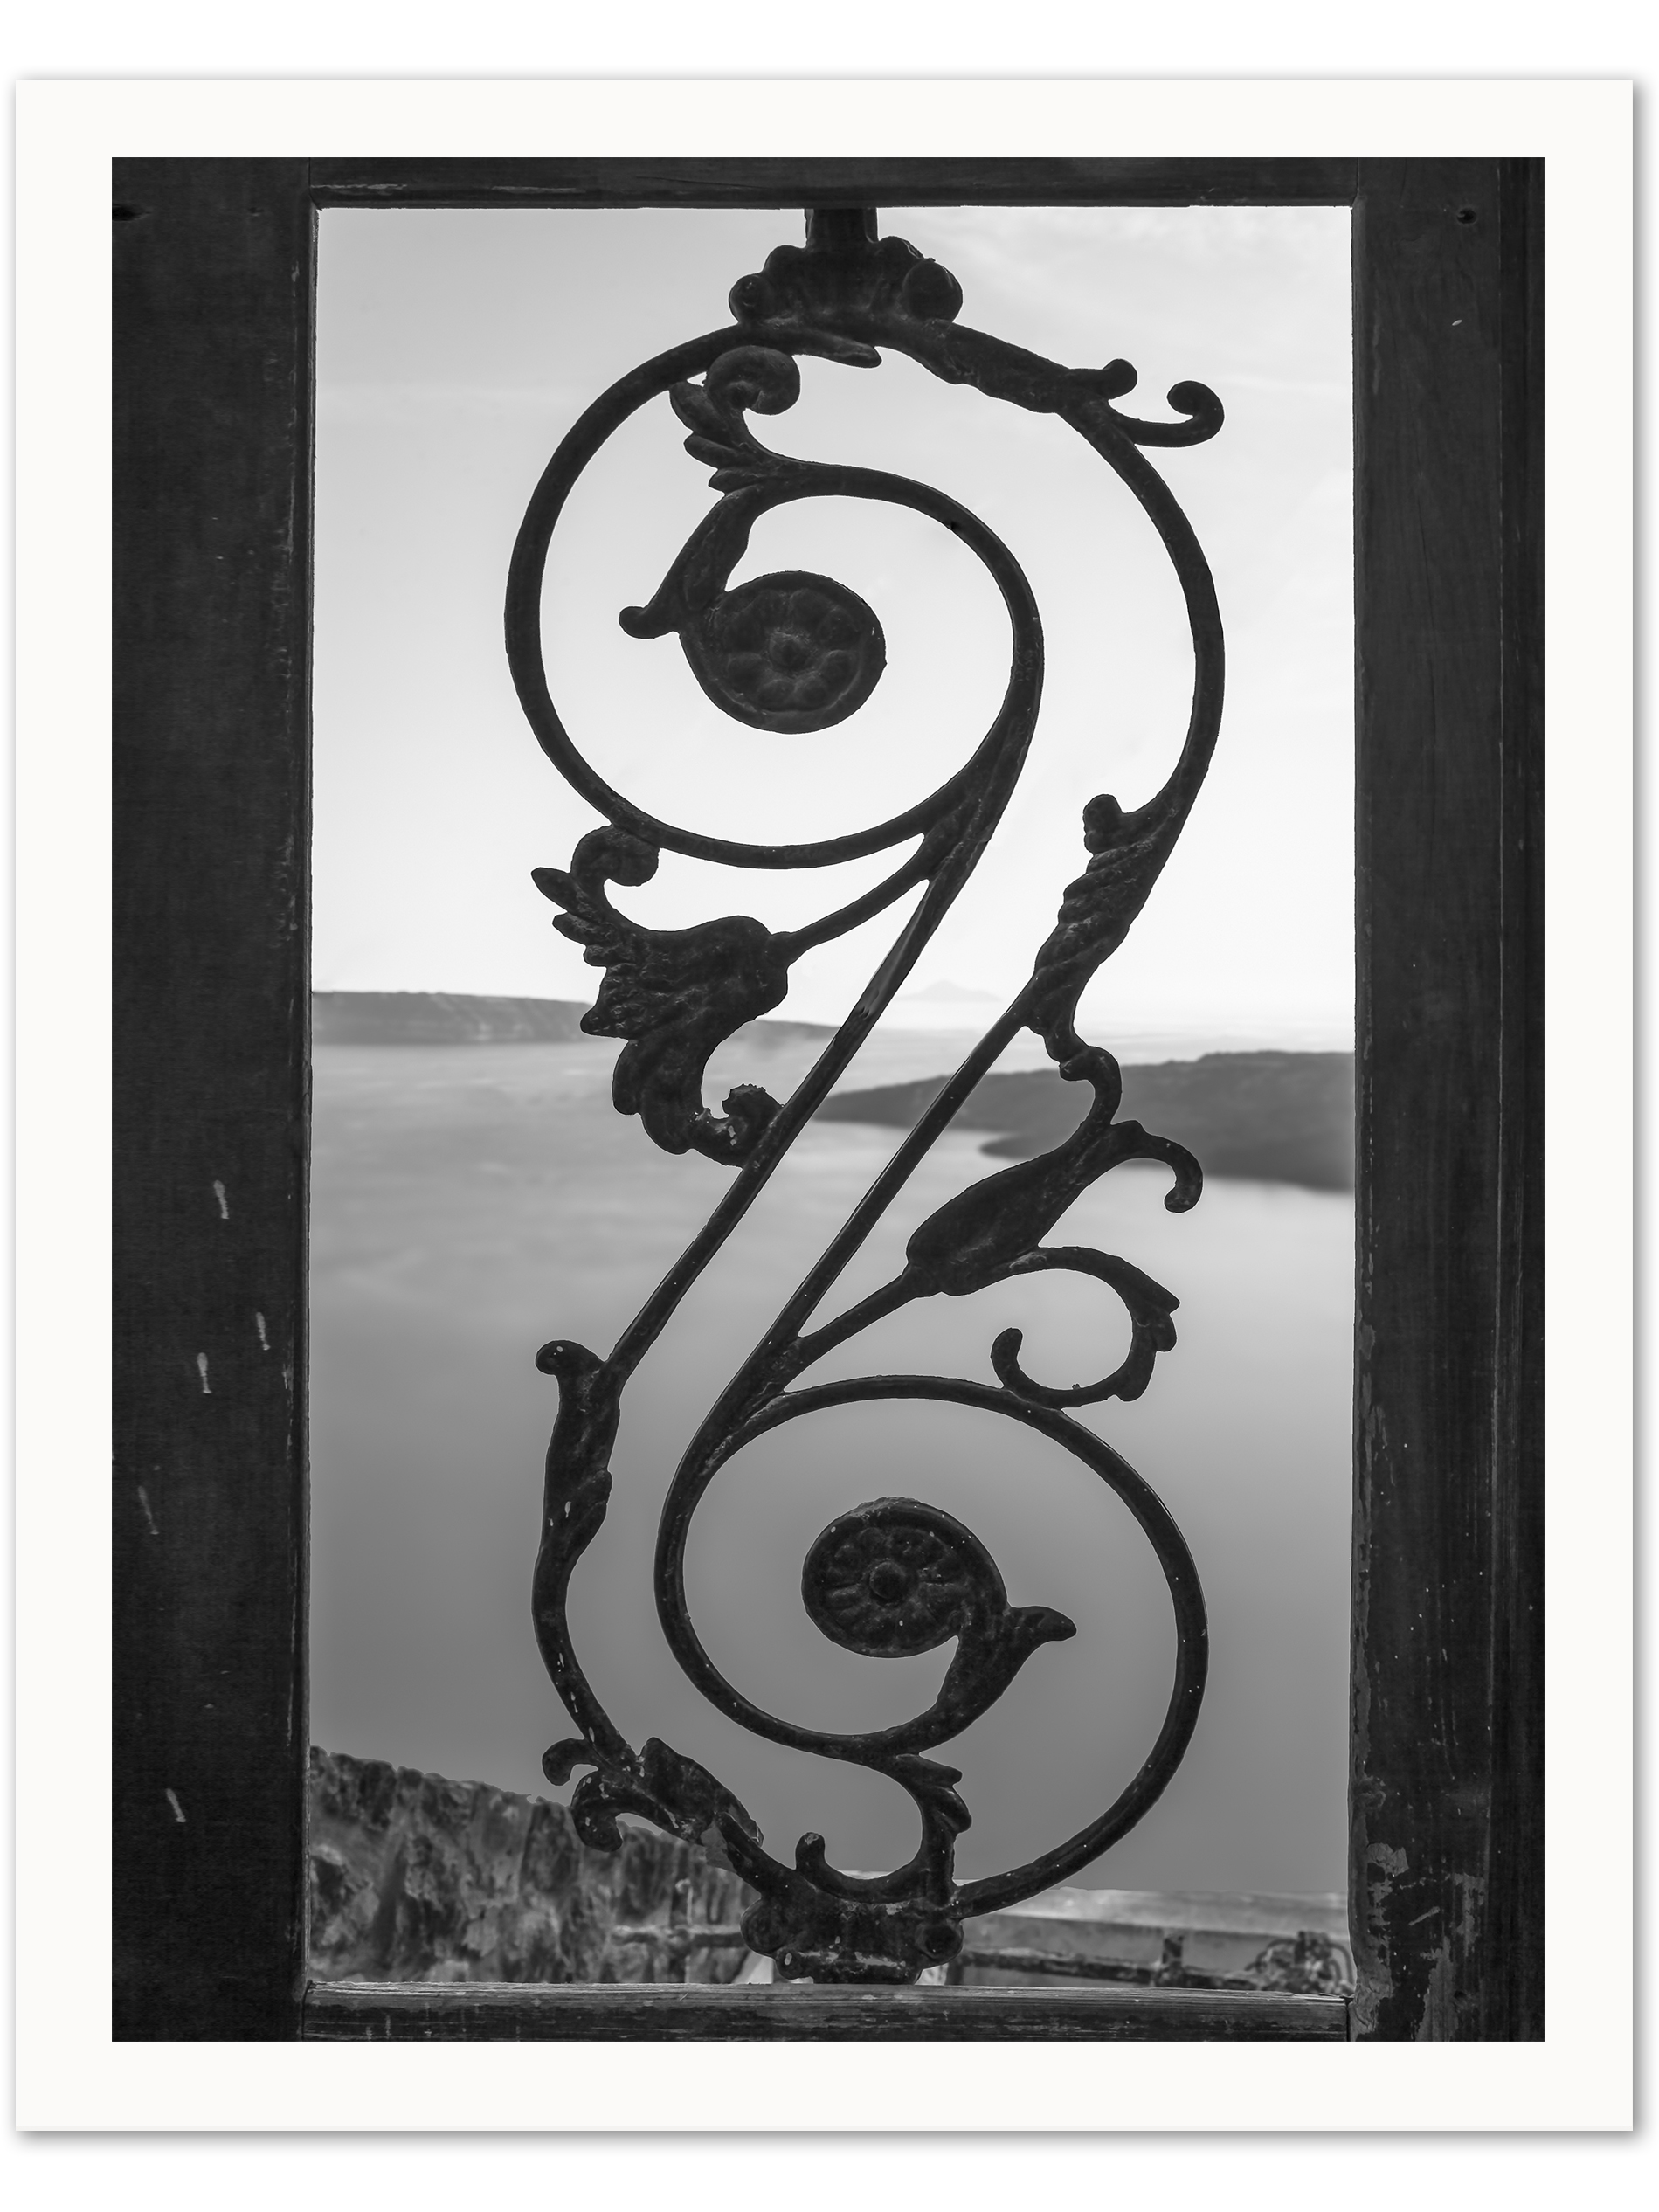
<box><xmin>315</xmin><ymin>208</ymin><xmax>1354</xmax><ymax>1047</ymax></box>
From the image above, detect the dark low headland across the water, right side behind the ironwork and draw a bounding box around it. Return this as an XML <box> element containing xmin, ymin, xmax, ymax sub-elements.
<box><xmin>819</xmin><ymin>1053</ymin><xmax>1354</xmax><ymax>1190</ymax></box>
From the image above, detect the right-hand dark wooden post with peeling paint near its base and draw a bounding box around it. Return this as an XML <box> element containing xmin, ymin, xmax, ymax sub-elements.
<box><xmin>1350</xmin><ymin>162</ymin><xmax>1544</xmax><ymax>2040</ymax></box>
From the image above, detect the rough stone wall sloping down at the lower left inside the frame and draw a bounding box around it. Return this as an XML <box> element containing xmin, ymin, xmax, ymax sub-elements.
<box><xmin>309</xmin><ymin>1747</ymin><xmax>752</xmax><ymax>1982</ymax></box>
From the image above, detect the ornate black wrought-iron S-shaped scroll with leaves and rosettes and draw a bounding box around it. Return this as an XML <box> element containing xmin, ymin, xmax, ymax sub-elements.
<box><xmin>507</xmin><ymin>208</ymin><xmax>1223</xmax><ymax>1982</ymax></box>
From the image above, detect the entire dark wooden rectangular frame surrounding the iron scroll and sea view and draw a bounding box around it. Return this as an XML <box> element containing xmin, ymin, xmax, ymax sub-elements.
<box><xmin>113</xmin><ymin>159</ymin><xmax>1544</xmax><ymax>2040</ymax></box>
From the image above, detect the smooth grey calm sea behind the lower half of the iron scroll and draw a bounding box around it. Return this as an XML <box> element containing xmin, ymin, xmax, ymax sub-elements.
<box><xmin>312</xmin><ymin>1038</ymin><xmax>1354</xmax><ymax>1891</ymax></box>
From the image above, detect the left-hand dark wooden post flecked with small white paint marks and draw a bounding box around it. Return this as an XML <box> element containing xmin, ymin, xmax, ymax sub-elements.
<box><xmin>113</xmin><ymin>162</ymin><xmax>315</xmax><ymax>2037</ymax></box>
